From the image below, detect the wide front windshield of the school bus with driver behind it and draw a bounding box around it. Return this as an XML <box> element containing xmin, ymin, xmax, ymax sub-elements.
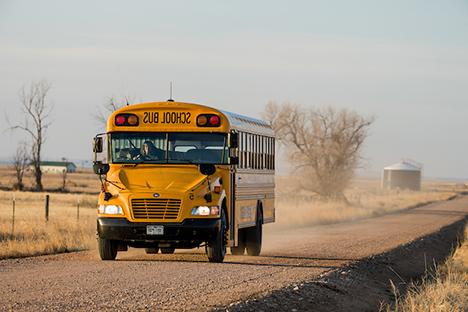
<box><xmin>110</xmin><ymin>132</ymin><xmax>228</xmax><ymax>164</ymax></box>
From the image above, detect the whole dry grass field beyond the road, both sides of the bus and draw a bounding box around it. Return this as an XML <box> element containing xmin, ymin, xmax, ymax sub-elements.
<box><xmin>0</xmin><ymin>163</ymin><xmax>465</xmax><ymax>259</ymax></box>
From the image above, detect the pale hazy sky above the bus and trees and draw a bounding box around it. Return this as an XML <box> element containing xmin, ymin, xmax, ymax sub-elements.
<box><xmin>0</xmin><ymin>0</ymin><xmax>468</xmax><ymax>179</ymax></box>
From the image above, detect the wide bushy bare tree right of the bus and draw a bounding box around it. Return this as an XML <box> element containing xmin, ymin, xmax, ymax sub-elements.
<box><xmin>264</xmin><ymin>102</ymin><xmax>373</xmax><ymax>200</ymax></box>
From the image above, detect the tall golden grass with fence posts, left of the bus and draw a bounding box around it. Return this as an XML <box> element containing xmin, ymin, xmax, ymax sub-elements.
<box><xmin>0</xmin><ymin>191</ymin><xmax>97</xmax><ymax>259</ymax></box>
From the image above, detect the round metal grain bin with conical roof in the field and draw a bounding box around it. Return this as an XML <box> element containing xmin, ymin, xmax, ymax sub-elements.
<box><xmin>382</xmin><ymin>160</ymin><xmax>422</xmax><ymax>191</ymax></box>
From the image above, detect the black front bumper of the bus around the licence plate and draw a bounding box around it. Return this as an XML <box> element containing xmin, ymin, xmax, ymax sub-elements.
<box><xmin>97</xmin><ymin>218</ymin><xmax>220</xmax><ymax>244</ymax></box>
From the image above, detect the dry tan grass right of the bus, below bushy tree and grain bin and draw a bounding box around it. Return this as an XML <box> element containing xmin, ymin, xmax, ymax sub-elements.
<box><xmin>269</xmin><ymin>177</ymin><xmax>465</xmax><ymax>230</ymax></box>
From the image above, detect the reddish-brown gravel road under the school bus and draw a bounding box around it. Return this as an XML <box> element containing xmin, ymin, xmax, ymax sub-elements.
<box><xmin>0</xmin><ymin>196</ymin><xmax>468</xmax><ymax>311</ymax></box>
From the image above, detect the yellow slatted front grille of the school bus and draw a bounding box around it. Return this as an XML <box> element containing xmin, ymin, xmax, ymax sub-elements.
<box><xmin>132</xmin><ymin>198</ymin><xmax>181</xmax><ymax>220</ymax></box>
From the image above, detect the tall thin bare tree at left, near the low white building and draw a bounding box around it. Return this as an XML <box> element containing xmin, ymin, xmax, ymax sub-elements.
<box><xmin>11</xmin><ymin>80</ymin><xmax>52</xmax><ymax>191</ymax></box>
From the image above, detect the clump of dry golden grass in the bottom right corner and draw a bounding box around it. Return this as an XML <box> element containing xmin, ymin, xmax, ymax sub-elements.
<box><xmin>381</xmin><ymin>227</ymin><xmax>468</xmax><ymax>312</ymax></box>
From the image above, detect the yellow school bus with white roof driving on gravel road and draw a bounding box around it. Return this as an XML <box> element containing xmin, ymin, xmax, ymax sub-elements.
<box><xmin>93</xmin><ymin>100</ymin><xmax>275</xmax><ymax>262</ymax></box>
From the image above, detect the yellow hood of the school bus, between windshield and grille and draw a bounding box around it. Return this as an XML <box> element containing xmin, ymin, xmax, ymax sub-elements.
<box><xmin>111</xmin><ymin>165</ymin><xmax>206</xmax><ymax>192</ymax></box>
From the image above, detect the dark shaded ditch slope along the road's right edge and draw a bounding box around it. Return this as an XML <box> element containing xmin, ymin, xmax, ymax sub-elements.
<box><xmin>221</xmin><ymin>218</ymin><xmax>466</xmax><ymax>311</ymax></box>
